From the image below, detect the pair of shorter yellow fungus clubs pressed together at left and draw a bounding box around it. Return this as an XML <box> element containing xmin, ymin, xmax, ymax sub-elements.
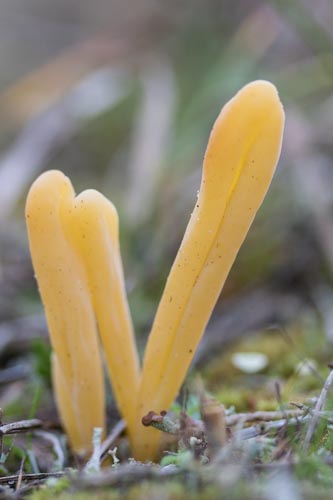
<box><xmin>26</xmin><ymin>171</ymin><xmax>139</xmax><ymax>454</ymax></box>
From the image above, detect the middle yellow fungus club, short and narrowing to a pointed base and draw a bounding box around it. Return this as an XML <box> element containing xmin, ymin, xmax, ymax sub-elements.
<box><xmin>64</xmin><ymin>189</ymin><xmax>140</xmax><ymax>444</ymax></box>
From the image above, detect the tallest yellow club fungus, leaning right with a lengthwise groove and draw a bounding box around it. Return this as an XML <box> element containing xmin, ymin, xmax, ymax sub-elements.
<box><xmin>134</xmin><ymin>81</ymin><xmax>284</xmax><ymax>460</ymax></box>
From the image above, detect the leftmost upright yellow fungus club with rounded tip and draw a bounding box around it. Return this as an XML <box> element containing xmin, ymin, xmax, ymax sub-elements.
<box><xmin>26</xmin><ymin>171</ymin><xmax>105</xmax><ymax>454</ymax></box>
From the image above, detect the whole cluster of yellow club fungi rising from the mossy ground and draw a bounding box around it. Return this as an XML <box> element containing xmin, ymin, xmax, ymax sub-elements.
<box><xmin>26</xmin><ymin>81</ymin><xmax>284</xmax><ymax>460</ymax></box>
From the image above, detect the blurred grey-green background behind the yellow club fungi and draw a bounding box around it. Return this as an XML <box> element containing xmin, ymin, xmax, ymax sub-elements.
<box><xmin>0</xmin><ymin>0</ymin><xmax>333</xmax><ymax>422</ymax></box>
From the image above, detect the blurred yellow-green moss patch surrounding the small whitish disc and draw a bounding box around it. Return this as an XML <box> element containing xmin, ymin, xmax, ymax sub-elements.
<box><xmin>202</xmin><ymin>314</ymin><xmax>332</xmax><ymax>411</ymax></box>
